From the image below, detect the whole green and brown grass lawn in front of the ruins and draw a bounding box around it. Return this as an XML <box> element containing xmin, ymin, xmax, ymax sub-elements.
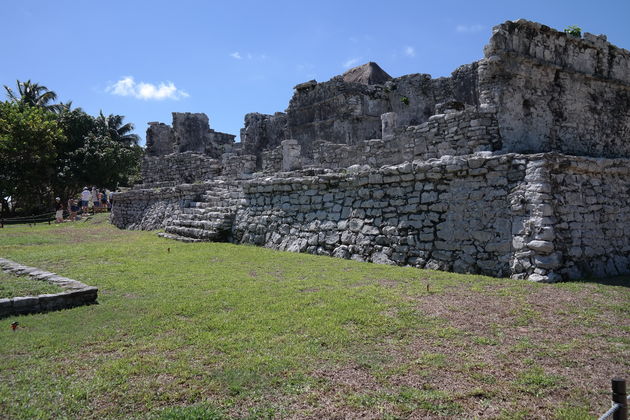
<box><xmin>0</xmin><ymin>214</ymin><xmax>630</xmax><ymax>420</ymax></box>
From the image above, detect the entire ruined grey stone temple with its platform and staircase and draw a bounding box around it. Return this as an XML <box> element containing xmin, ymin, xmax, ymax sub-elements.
<box><xmin>111</xmin><ymin>20</ymin><xmax>630</xmax><ymax>281</ymax></box>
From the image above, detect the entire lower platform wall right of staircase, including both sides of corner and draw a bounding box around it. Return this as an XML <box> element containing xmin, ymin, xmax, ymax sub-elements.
<box><xmin>233</xmin><ymin>153</ymin><xmax>630</xmax><ymax>281</ymax></box>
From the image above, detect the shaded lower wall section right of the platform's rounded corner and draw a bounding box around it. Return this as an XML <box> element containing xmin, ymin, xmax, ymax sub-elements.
<box><xmin>549</xmin><ymin>155</ymin><xmax>630</xmax><ymax>278</ymax></box>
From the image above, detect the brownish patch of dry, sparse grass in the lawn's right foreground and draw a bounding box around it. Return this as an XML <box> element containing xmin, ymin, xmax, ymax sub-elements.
<box><xmin>232</xmin><ymin>282</ymin><xmax>630</xmax><ymax>419</ymax></box>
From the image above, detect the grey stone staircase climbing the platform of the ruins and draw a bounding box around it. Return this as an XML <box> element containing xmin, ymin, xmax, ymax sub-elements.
<box><xmin>158</xmin><ymin>181</ymin><xmax>243</xmax><ymax>242</ymax></box>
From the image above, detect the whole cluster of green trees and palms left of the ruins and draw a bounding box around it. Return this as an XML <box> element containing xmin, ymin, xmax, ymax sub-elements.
<box><xmin>0</xmin><ymin>80</ymin><xmax>142</xmax><ymax>213</ymax></box>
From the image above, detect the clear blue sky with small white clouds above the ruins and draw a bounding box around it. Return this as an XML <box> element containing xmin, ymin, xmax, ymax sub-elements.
<box><xmin>0</xmin><ymin>0</ymin><xmax>630</xmax><ymax>143</ymax></box>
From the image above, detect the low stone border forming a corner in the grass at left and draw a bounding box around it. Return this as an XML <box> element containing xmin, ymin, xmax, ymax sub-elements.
<box><xmin>0</xmin><ymin>258</ymin><xmax>98</xmax><ymax>318</ymax></box>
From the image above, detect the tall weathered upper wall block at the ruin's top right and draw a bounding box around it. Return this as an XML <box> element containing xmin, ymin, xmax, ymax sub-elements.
<box><xmin>478</xmin><ymin>20</ymin><xmax>630</xmax><ymax>157</ymax></box>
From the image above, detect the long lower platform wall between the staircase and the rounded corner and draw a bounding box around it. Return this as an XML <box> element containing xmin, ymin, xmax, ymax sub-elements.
<box><xmin>233</xmin><ymin>155</ymin><xmax>527</xmax><ymax>276</ymax></box>
